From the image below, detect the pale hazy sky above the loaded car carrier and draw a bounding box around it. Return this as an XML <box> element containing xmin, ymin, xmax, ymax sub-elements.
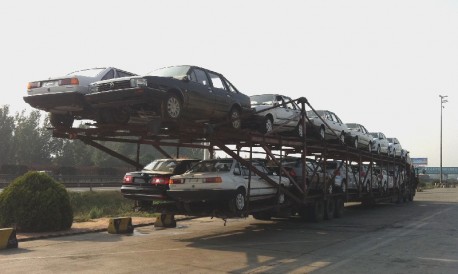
<box><xmin>0</xmin><ymin>0</ymin><xmax>458</xmax><ymax>167</ymax></box>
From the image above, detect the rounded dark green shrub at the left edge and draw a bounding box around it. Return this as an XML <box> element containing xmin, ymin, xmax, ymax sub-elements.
<box><xmin>0</xmin><ymin>171</ymin><xmax>73</xmax><ymax>232</ymax></box>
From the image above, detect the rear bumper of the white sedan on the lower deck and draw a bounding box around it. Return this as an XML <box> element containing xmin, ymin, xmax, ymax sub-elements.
<box><xmin>167</xmin><ymin>189</ymin><xmax>237</xmax><ymax>202</ymax></box>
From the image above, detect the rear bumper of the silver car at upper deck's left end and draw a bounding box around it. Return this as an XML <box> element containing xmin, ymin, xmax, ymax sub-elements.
<box><xmin>23</xmin><ymin>92</ymin><xmax>89</xmax><ymax>112</ymax></box>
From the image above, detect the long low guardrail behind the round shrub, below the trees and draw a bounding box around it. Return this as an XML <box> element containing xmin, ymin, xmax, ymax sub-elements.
<box><xmin>0</xmin><ymin>174</ymin><xmax>122</xmax><ymax>188</ymax></box>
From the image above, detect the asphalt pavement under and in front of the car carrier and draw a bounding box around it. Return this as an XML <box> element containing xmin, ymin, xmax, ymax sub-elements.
<box><xmin>0</xmin><ymin>188</ymin><xmax>458</xmax><ymax>274</ymax></box>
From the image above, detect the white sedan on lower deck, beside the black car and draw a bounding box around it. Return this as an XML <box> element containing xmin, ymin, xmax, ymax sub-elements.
<box><xmin>167</xmin><ymin>158</ymin><xmax>290</xmax><ymax>214</ymax></box>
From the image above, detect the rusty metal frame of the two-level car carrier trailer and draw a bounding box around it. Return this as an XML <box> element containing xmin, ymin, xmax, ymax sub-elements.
<box><xmin>53</xmin><ymin>97</ymin><xmax>416</xmax><ymax>221</ymax></box>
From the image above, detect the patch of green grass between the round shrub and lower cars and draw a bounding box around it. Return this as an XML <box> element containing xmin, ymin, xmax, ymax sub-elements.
<box><xmin>68</xmin><ymin>191</ymin><xmax>156</xmax><ymax>222</ymax></box>
